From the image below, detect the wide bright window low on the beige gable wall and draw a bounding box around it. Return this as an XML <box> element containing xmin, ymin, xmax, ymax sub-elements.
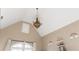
<box><xmin>5</xmin><ymin>40</ymin><xmax>35</xmax><ymax>51</ymax></box>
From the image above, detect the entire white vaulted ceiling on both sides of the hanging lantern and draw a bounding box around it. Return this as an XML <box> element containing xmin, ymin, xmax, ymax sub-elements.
<box><xmin>0</xmin><ymin>8</ymin><xmax>79</xmax><ymax>36</ymax></box>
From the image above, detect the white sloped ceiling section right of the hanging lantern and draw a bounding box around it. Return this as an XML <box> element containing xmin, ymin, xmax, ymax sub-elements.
<box><xmin>39</xmin><ymin>8</ymin><xmax>79</xmax><ymax>36</ymax></box>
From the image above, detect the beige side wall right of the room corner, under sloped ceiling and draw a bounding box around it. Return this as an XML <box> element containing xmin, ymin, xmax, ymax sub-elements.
<box><xmin>43</xmin><ymin>20</ymin><xmax>79</xmax><ymax>51</ymax></box>
